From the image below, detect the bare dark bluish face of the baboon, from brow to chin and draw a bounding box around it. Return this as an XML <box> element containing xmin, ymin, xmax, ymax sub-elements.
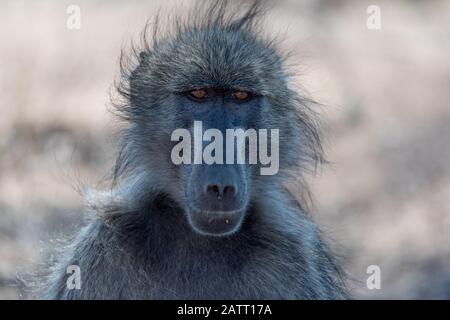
<box><xmin>172</xmin><ymin>87</ymin><xmax>264</xmax><ymax>235</ymax></box>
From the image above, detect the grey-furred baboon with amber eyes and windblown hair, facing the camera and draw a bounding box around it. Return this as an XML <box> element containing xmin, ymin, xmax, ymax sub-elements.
<box><xmin>40</xmin><ymin>0</ymin><xmax>348</xmax><ymax>299</ymax></box>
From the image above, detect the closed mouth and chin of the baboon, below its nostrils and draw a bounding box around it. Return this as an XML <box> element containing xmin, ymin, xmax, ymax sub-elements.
<box><xmin>187</xmin><ymin>209</ymin><xmax>245</xmax><ymax>236</ymax></box>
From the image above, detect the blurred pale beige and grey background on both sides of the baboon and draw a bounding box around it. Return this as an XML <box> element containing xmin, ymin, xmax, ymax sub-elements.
<box><xmin>0</xmin><ymin>0</ymin><xmax>450</xmax><ymax>299</ymax></box>
